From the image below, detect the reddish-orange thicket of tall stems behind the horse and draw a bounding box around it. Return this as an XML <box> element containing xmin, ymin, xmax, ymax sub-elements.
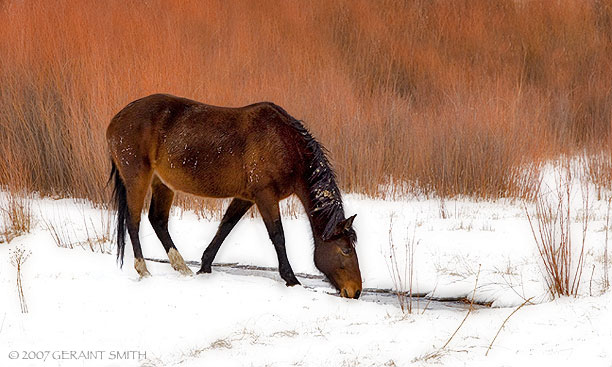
<box><xmin>0</xmin><ymin>0</ymin><xmax>612</xmax><ymax>211</ymax></box>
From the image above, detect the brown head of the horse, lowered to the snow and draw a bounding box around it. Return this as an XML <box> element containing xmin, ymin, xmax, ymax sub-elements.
<box><xmin>315</xmin><ymin>215</ymin><xmax>361</xmax><ymax>299</ymax></box>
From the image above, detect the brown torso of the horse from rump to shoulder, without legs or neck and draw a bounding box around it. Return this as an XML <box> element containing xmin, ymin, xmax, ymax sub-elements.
<box><xmin>107</xmin><ymin>94</ymin><xmax>300</xmax><ymax>199</ymax></box>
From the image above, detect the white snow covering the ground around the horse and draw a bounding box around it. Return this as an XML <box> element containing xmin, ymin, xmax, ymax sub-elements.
<box><xmin>0</xmin><ymin>178</ymin><xmax>612</xmax><ymax>367</ymax></box>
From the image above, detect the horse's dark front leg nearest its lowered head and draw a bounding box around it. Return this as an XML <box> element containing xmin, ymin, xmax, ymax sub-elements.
<box><xmin>256</xmin><ymin>200</ymin><xmax>300</xmax><ymax>286</ymax></box>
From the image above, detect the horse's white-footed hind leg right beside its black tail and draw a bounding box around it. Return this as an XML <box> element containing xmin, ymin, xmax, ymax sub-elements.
<box><xmin>124</xmin><ymin>165</ymin><xmax>152</xmax><ymax>278</ymax></box>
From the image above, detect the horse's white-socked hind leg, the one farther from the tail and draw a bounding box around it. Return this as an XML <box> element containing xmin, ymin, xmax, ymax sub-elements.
<box><xmin>149</xmin><ymin>176</ymin><xmax>193</xmax><ymax>275</ymax></box>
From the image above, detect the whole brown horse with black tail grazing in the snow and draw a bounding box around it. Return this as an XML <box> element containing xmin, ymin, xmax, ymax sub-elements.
<box><xmin>106</xmin><ymin>94</ymin><xmax>362</xmax><ymax>298</ymax></box>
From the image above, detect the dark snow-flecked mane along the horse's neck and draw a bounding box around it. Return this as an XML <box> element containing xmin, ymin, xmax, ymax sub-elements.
<box><xmin>271</xmin><ymin>104</ymin><xmax>344</xmax><ymax>238</ymax></box>
